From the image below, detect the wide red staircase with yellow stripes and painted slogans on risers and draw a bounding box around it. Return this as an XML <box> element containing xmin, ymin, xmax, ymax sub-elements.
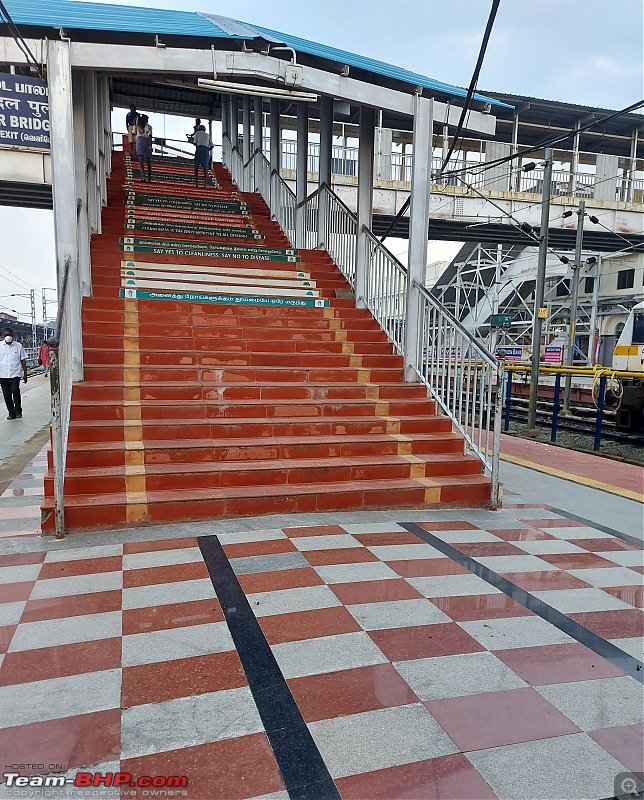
<box><xmin>43</xmin><ymin>153</ymin><xmax>490</xmax><ymax>530</ymax></box>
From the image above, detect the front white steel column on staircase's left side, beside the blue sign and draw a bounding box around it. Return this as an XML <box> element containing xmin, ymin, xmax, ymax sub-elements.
<box><xmin>47</xmin><ymin>39</ymin><xmax>83</xmax><ymax>380</ymax></box>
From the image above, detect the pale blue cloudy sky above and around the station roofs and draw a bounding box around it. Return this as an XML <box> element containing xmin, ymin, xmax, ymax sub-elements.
<box><xmin>0</xmin><ymin>0</ymin><xmax>644</xmax><ymax>318</ymax></box>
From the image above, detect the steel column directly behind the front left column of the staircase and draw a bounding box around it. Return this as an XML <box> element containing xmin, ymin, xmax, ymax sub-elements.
<box><xmin>72</xmin><ymin>72</ymin><xmax>92</xmax><ymax>296</ymax></box>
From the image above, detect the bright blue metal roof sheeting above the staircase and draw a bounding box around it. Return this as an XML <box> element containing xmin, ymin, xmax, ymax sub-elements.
<box><xmin>5</xmin><ymin>0</ymin><xmax>512</xmax><ymax>108</ymax></box>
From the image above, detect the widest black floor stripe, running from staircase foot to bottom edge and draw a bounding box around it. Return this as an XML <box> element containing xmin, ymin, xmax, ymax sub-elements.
<box><xmin>197</xmin><ymin>536</ymin><xmax>340</xmax><ymax>800</ymax></box>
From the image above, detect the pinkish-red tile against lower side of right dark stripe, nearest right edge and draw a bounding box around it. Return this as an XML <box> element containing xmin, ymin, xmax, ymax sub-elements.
<box><xmin>494</xmin><ymin>642</ymin><xmax>624</xmax><ymax>686</ymax></box>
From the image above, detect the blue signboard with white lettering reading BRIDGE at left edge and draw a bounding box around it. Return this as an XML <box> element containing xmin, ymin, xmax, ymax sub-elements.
<box><xmin>0</xmin><ymin>72</ymin><xmax>49</xmax><ymax>150</ymax></box>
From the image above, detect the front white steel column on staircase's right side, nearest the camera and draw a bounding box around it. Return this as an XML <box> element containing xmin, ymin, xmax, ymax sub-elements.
<box><xmin>403</xmin><ymin>94</ymin><xmax>434</xmax><ymax>381</ymax></box>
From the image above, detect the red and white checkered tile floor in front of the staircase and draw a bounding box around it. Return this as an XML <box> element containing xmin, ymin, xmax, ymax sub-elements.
<box><xmin>0</xmin><ymin>484</ymin><xmax>644</xmax><ymax>800</ymax></box>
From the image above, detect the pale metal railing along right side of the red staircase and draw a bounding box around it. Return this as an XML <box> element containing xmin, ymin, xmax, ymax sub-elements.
<box><xmin>230</xmin><ymin>148</ymin><xmax>503</xmax><ymax>508</ymax></box>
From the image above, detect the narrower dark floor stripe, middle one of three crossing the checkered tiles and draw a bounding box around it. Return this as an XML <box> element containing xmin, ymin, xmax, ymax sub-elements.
<box><xmin>398</xmin><ymin>522</ymin><xmax>644</xmax><ymax>683</ymax></box>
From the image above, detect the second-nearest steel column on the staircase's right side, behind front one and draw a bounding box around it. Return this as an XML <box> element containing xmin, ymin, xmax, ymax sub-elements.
<box><xmin>355</xmin><ymin>106</ymin><xmax>376</xmax><ymax>308</ymax></box>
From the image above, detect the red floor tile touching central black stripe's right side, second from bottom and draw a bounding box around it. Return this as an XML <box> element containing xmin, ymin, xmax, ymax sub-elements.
<box><xmin>288</xmin><ymin>664</ymin><xmax>418</xmax><ymax>722</ymax></box>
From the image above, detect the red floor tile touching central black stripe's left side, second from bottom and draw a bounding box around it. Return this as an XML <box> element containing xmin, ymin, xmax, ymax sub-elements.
<box><xmin>121</xmin><ymin>650</ymin><xmax>246</xmax><ymax>708</ymax></box>
